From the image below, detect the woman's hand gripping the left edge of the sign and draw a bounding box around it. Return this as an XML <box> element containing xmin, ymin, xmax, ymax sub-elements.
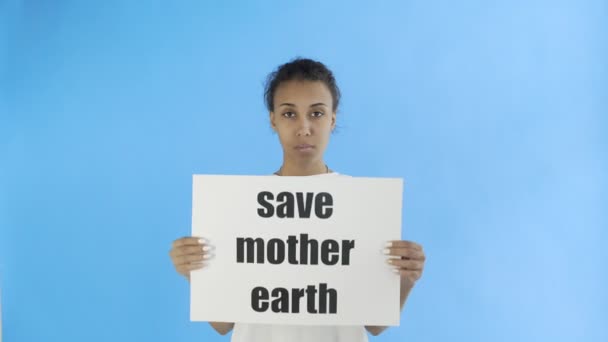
<box><xmin>169</xmin><ymin>237</ymin><xmax>213</xmax><ymax>281</ymax></box>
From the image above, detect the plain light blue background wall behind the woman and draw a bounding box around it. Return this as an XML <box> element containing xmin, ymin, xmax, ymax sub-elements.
<box><xmin>0</xmin><ymin>0</ymin><xmax>608</xmax><ymax>342</ymax></box>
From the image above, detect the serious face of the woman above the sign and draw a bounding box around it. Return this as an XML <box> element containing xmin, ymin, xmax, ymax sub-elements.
<box><xmin>270</xmin><ymin>81</ymin><xmax>336</xmax><ymax>161</ymax></box>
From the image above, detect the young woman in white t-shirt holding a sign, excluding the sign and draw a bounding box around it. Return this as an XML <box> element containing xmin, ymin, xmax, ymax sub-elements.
<box><xmin>170</xmin><ymin>59</ymin><xmax>425</xmax><ymax>342</ymax></box>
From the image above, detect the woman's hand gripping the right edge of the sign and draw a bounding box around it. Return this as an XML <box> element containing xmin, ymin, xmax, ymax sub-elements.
<box><xmin>384</xmin><ymin>240</ymin><xmax>426</xmax><ymax>287</ymax></box>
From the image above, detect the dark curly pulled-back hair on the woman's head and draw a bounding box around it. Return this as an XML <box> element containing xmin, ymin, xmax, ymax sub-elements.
<box><xmin>264</xmin><ymin>57</ymin><xmax>340</xmax><ymax>112</ymax></box>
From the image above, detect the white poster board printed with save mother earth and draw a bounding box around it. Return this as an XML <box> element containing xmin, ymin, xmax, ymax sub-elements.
<box><xmin>190</xmin><ymin>175</ymin><xmax>403</xmax><ymax>326</ymax></box>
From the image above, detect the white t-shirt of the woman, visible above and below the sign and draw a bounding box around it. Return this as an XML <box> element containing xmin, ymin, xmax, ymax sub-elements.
<box><xmin>231</xmin><ymin>172</ymin><xmax>368</xmax><ymax>342</ymax></box>
